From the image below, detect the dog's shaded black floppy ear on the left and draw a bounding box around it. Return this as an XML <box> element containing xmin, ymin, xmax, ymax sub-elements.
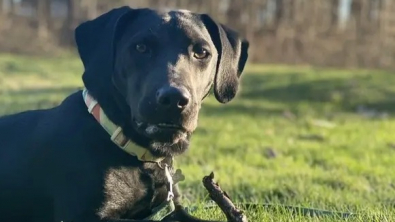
<box><xmin>75</xmin><ymin>6</ymin><xmax>138</xmax><ymax>101</ymax></box>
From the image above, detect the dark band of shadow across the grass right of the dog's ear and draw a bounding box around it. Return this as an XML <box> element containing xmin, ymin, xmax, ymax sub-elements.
<box><xmin>239</xmin><ymin>73</ymin><xmax>395</xmax><ymax>114</ymax></box>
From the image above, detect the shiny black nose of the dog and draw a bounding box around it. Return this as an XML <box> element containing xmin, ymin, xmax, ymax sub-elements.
<box><xmin>156</xmin><ymin>86</ymin><xmax>191</xmax><ymax>110</ymax></box>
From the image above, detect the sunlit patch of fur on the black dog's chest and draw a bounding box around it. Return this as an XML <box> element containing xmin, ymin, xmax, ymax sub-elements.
<box><xmin>99</xmin><ymin>166</ymin><xmax>168</xmax><ymax>219</ymax></box>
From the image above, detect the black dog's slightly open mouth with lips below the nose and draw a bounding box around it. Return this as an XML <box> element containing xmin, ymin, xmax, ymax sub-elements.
<box><xmin>133</xmin><ymin>118</ymin><xmax>188</xmax><ymax>144</ymax></box>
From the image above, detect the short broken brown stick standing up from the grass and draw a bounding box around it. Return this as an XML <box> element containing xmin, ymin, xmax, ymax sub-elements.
<box><xmin>203</xmin><ymin>172</ymin><xmax>248</xmax><ymax>222</ymax></box>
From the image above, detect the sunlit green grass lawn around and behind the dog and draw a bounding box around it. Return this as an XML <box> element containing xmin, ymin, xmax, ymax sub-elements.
<box><xmin>0</xmin><ymin>55</ymin><xmax>395</xmax><ymax>221</ymax></box>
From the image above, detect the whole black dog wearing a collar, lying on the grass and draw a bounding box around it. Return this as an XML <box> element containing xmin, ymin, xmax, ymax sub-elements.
<box><xmin>0</xmin><ymin>7</ymin><xmax>249</xmax><ymax>222</ymax></box>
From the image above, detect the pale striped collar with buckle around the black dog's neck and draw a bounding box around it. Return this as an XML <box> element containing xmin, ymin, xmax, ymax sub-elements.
<box><xmin>82</xmin><ymin>89</ymin><xmax>164</xmax><ymax>163</ymax></box>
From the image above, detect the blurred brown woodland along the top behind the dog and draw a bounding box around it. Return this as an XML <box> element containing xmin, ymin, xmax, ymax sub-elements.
<box><xmin>0</xmin><ymin>0</ymin><xmax>395</xmax><ymax>68</ymax></box>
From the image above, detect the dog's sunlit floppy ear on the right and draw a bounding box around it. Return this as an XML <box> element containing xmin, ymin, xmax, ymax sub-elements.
<box><xmin>201</xmin><ymin>14</ymin><xmax>249</xmax><ymax>103</ymax></box>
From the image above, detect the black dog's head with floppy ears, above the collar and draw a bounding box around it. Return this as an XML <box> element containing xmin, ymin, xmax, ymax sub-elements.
<box><xmin>75</xmin><ymin>6</ymin><xmax>249</xmax><ymax>155</ymax></box>
